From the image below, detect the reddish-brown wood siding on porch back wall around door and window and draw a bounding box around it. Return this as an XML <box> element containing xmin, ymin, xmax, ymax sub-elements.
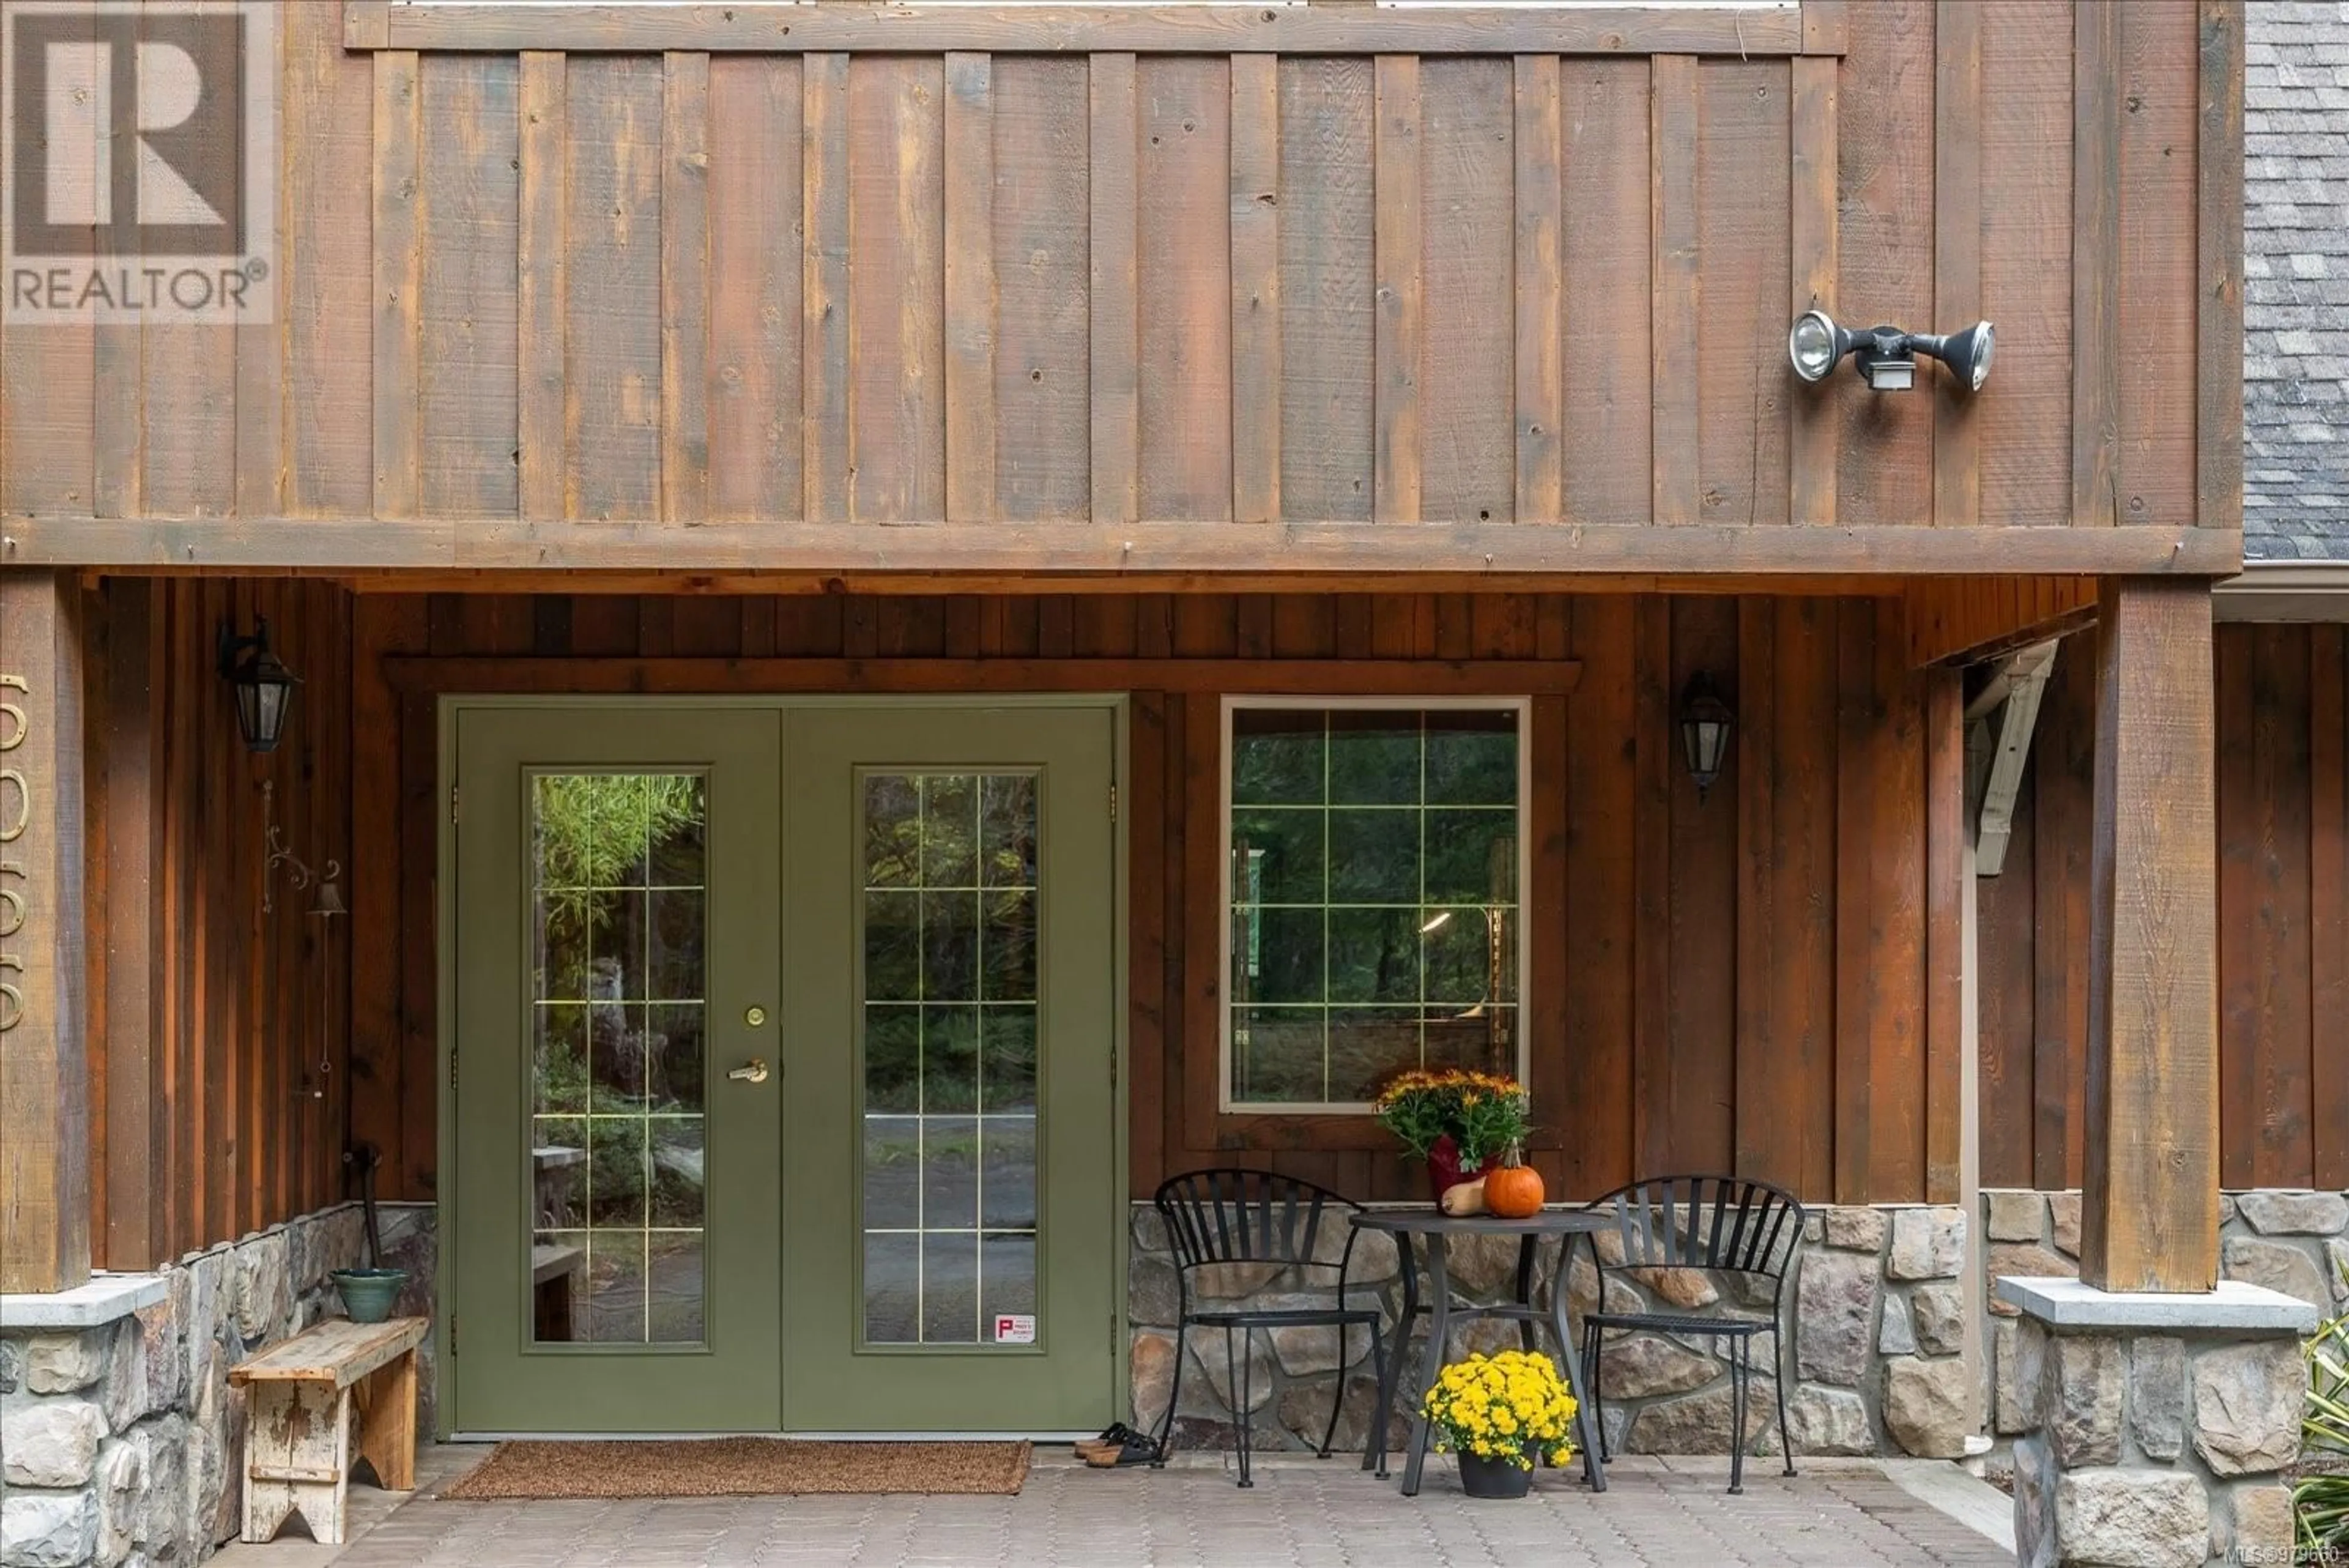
<box><xmin>350</xmin><ymin>595</ymin><xmax>1959</xmax><ymax>1202</ymax></box>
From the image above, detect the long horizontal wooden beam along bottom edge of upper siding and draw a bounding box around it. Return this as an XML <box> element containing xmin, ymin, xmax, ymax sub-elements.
<box><xmin>0</xmin><ymin>522</ymin><xmax>2243</xmax><ymax>582</ymax></box>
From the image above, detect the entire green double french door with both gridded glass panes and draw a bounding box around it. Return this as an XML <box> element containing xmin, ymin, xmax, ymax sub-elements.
<box><xmin>442</xmin><ymin>703</ymin><xmax>1123</xmax><ymax>1434</ymax></box>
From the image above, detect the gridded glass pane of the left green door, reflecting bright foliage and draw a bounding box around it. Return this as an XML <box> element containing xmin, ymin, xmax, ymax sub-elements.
<box><xmin>529</xmin><ymin>773</ymin><xmax>710</xmax><ymax>1345</ymax></box>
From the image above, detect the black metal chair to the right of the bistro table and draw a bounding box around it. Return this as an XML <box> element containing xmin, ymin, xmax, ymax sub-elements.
<box><xmin>1583</xmin><ymin>1175</ymin><xmax>1804</xmax><ymax>1495</ymax></box>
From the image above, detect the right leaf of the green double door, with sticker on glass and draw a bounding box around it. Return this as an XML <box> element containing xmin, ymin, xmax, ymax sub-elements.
<box><xmin>782</xmin><ymin>708</ymin><xmax>1123</xmax><ymax>1432</ymax></box>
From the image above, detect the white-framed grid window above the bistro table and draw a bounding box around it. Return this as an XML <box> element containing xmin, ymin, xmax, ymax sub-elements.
<box><xmin>1224</xmin><ymin>700</ymin><xmax>1524</xmax><ymax>1110</ymax></box>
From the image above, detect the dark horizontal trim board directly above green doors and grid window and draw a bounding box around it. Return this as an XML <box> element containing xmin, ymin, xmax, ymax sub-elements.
<box><xmin>383</xmin><ymin>656</ymin><xmax>1583</xmax><ymax>696</ymax></box>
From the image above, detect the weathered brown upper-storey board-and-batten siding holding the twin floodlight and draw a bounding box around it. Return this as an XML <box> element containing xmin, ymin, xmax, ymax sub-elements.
<box><xmin>0</xmin><ymin>0</ymin><xmax>2239</xmax><ymax>585</ymax></box>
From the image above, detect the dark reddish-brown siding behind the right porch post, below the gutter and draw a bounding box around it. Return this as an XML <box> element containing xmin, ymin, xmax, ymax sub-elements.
<box><xmin>1978</xmin><ymin>625</ymin><xmax>2349</xmax><ymax>1187</ymax></box>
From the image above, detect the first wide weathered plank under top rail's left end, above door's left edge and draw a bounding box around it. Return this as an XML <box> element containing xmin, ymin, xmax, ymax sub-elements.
<box><xmin>416</xmin><ymin>54</ymin><xmax>521</xmax><ymax>517</ymax></box>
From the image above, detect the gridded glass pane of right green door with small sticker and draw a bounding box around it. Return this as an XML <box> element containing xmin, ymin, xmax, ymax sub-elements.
<box><xmin>858</xmin><ymin>773</ymin><xmax>1038</xmax><ymax>1345</ymax></box>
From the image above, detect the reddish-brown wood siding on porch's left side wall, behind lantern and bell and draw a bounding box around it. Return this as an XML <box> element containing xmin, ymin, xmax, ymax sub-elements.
<box><xmin>82</xmin><ymin>578</ymin><xmax>352</xmax><ymax>1269</ymax></box>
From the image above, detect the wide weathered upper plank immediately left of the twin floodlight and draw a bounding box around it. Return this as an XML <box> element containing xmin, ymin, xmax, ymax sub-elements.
<box><xmin>1691</xmin><ymin>61</ymin><xmax>1792</xmax><ymax>524</ymax></box>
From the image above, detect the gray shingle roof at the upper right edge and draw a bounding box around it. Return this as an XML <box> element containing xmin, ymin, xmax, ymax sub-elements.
<box><xmin>2243</xmin><ymin>0</ymin><xmax>2349</xmax><ymax>560</ymax></box>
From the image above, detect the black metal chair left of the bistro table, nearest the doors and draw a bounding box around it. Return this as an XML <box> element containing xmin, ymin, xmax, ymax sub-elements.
<box><xmin>1151</xmin><ymin>1169</ymin><xmax>1386</xmax><ymax>1486</ymax></box>
